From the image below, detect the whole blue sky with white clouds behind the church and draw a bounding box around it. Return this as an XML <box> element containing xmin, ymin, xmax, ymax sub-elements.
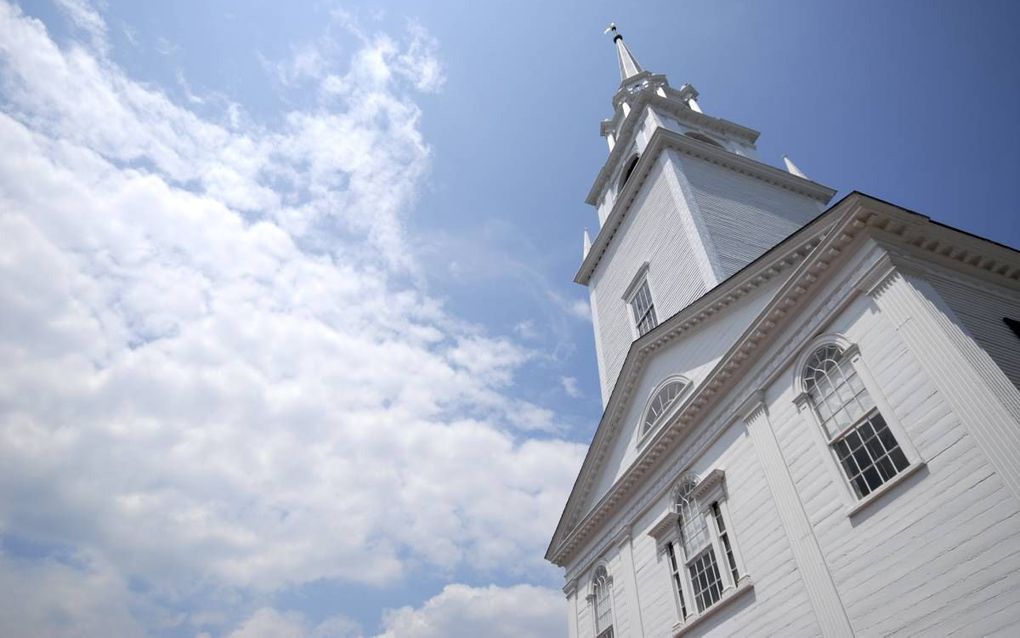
<box><xmin>0</xmin><ymin>0</ymin><xmax>1020</xmax><ymax>637</ymax></box>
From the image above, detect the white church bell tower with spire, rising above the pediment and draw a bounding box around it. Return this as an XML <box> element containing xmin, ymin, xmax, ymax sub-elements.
<box><xmin>574</xmin><ymin>24</ymin><xmax>835</xmax><ymax>405</ymax></box>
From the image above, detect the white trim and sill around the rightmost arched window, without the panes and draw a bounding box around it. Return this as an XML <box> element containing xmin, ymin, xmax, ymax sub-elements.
<box><xmin>794</xmin><ymin>333</ymin><xmax>925</xmax><ymax>518</ymax></box>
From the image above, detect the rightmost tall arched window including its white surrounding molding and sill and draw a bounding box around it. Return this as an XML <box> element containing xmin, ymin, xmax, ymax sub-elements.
<box><xmin>794</xmin><ymin>334</ymin><xmax>924</xmax><ymax>508</ymax></box>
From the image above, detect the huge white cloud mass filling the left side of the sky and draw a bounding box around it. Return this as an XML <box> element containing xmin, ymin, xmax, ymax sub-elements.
<box><xmin>0</xmin><ymin>0</ymin><xmax>583</xmax><ymax>635</ymax></box>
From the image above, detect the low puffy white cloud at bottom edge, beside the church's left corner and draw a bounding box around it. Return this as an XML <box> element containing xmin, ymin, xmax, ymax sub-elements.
<box><xmin>378</xmin><ymin>585</ymin><xmax>567</xmax><ymax>638</ymax></box>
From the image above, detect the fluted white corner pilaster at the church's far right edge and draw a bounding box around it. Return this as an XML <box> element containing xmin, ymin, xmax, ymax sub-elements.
<box><xmin>868</xmin><ymin>271</ymin><xmax>1020</xmax><ymax>500</ymax></box>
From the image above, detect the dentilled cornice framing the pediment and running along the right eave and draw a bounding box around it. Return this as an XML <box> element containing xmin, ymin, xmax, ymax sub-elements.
<box><xmin>546</xmin><ymin>192</ymin><xmax>1020</xmax><ymax>566</ymax></box>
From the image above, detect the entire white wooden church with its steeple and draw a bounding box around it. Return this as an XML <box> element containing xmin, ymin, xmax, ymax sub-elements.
<box><xmin>546</xmin><ymin>28</ymin><xmax>1020</xmax><ymax>638</ymax></box>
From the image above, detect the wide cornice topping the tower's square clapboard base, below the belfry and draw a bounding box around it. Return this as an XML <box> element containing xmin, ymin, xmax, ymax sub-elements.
<box><xmin>574</xmin><ymin>128</ymin><xmax>835</xmax><ymax>286</ymax></box>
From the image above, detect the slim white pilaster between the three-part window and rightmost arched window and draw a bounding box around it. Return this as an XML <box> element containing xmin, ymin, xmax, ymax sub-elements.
<box><xmin>744</xmin><ymin>393</ymin><xmax>854</xmax><ymax>636</ymax></box>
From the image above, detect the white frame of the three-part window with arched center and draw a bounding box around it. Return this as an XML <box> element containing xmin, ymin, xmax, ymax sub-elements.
<box><xmin>649</xmin><ymin>470</ymin><xmax>751</xmax><ymax>627</ymax></box>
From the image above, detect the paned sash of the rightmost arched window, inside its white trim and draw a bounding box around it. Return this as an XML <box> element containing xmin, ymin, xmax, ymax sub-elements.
<box><xmin>802</xmin><ymin>343</ymin><xmax>910</xmax><ymax>498</ymax></box>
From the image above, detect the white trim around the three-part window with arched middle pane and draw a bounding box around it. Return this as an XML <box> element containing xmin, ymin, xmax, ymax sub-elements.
<box><xmin>649</xmin><ymin>469</ymin><xmax>754</xmax><ymax>636</ymax></box>
